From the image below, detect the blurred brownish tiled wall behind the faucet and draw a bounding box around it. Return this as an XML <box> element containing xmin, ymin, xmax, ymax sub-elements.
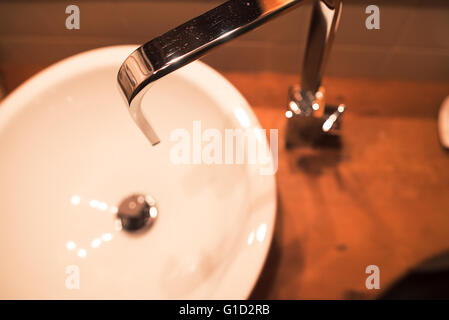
<box><xmin>0</xmin><ymin>0</ymin><xmax>449</xmax><ymax>81</ymax></box>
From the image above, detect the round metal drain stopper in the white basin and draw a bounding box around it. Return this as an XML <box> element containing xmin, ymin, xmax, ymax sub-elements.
<box><xmin>117</xmin><ymin>194</ymin><xmax>158</xmax><ymax>232</ymax></box>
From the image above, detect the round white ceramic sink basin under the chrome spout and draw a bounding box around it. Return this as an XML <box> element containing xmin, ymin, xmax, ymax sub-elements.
<box><xmin>0</xmin><ymin>46</ymin><xmax>276</xmax><ymax>299</ymax></box>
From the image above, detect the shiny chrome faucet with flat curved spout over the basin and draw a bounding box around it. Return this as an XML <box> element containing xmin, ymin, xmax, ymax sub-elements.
<box><xmin>117</xmin><ymin>0</ymin><xmax>344</xmax><ymax>145</ymax></box>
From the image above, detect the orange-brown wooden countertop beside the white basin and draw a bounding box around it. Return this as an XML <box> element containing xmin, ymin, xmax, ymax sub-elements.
<box><xmin>225</xmin><ymin>73</ymin><xmax>449</xmax><ymax>299</ymax></box>
